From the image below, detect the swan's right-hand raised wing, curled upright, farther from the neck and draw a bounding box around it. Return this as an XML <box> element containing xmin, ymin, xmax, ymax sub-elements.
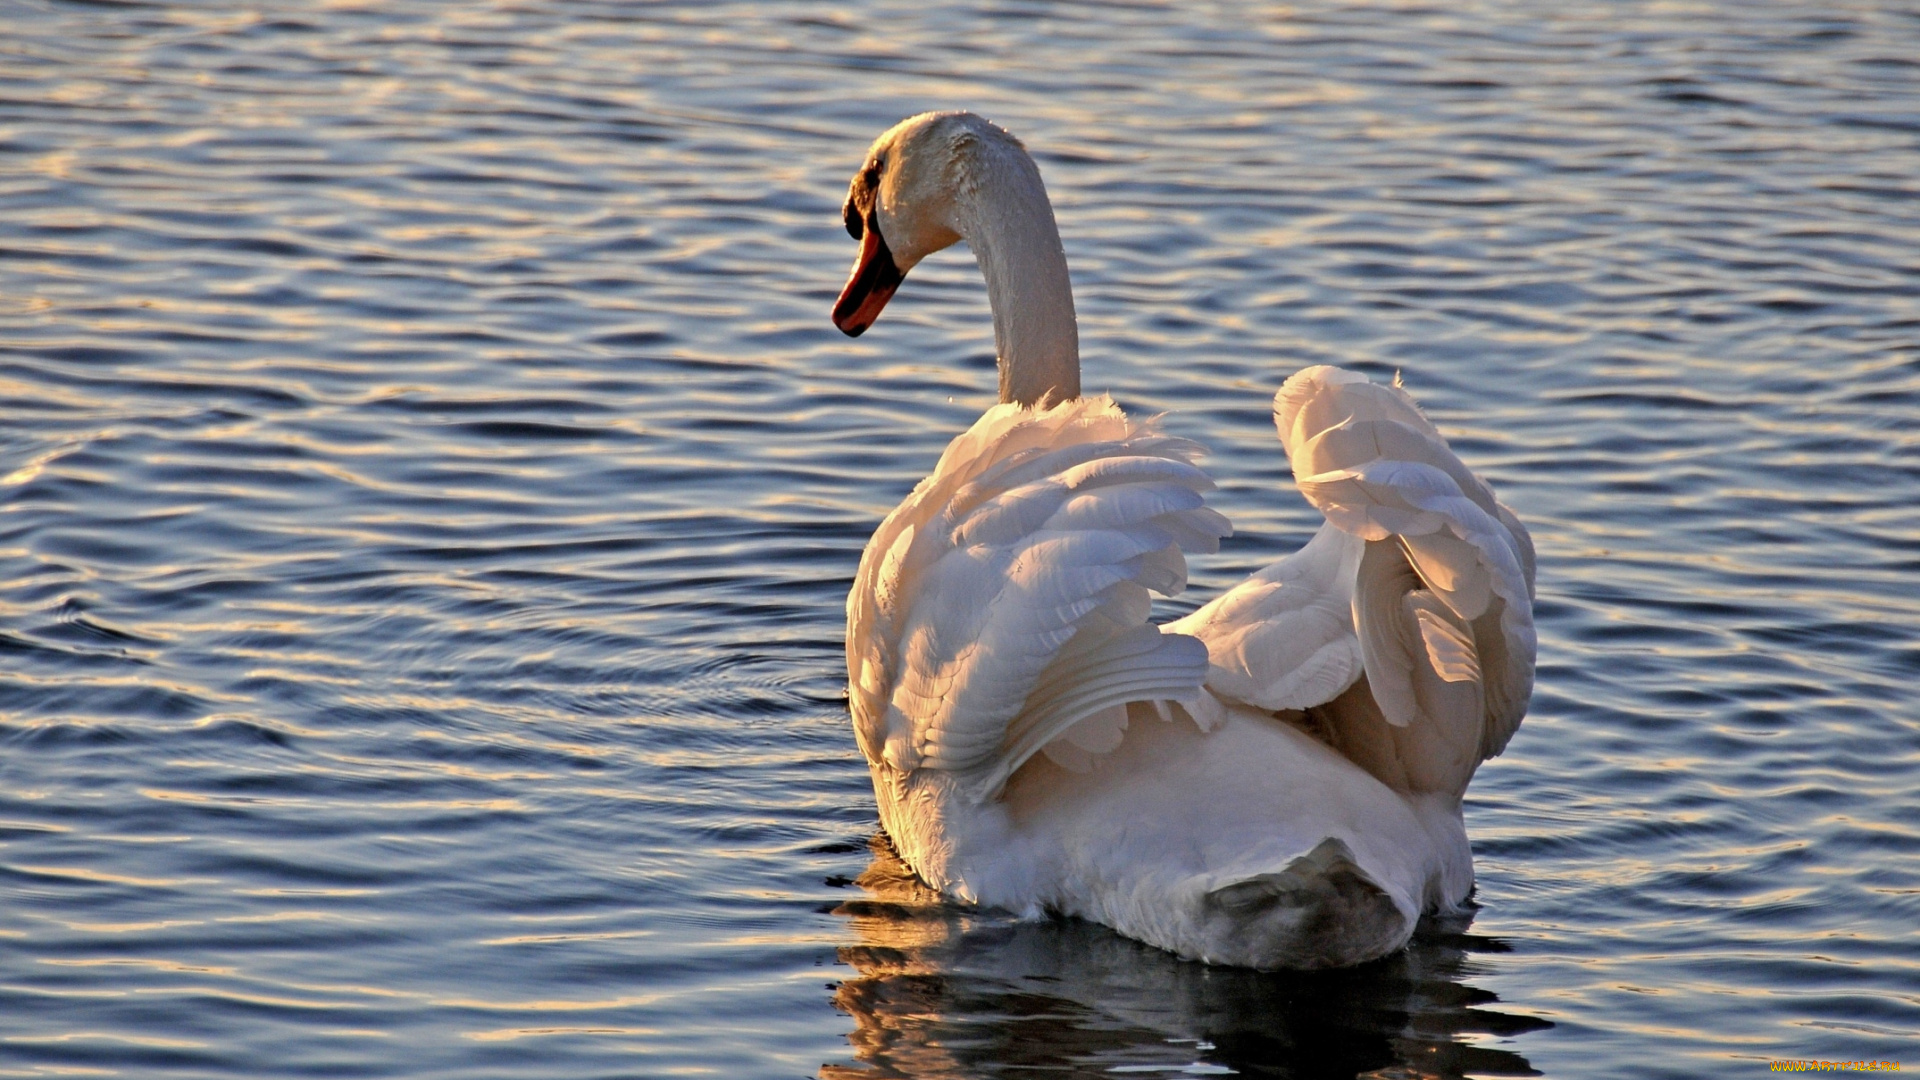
<box><xmin>1169</xmin><ymin>367</ymin><xmax>1534</xmax><ymax>794</ymax></box>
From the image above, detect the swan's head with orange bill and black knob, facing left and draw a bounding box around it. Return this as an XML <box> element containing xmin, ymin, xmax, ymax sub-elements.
<box><xmin>833</xmin><ymin>111</ymin><xmax>1039</xmax><ymax>338</ymax></box>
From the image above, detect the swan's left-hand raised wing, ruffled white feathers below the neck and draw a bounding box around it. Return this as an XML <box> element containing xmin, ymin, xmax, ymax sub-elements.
<box><xmin>847</xmin><ymin>396</ymin><xmax>1231</xmax><ymax>799</ymax></box>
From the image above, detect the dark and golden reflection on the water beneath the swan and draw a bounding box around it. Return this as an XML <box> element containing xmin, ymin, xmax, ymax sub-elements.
<box><xmin>822</xmin><ymin>836</ymin><xmax>1551</xmax><ymax>1080</ymax></box>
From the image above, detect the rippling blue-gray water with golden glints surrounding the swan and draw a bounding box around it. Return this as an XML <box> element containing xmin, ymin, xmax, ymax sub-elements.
<box><xmin>0</xmin><ymin>0</ymin><xmax>1920</xmax><ymax>1078</ymax></box>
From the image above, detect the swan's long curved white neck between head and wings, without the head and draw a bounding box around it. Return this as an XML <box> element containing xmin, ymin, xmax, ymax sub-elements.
<box><xmin>956</xmin><ymin>148</ymin><xmax>1079</xmax><ymax>405</ymax></box>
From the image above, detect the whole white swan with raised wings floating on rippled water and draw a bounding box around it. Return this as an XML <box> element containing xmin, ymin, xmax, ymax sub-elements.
<box><xmin>833</xmin><ymin>113</ymin><xmax>1534</xmax><ymax>967</ymax></box>
